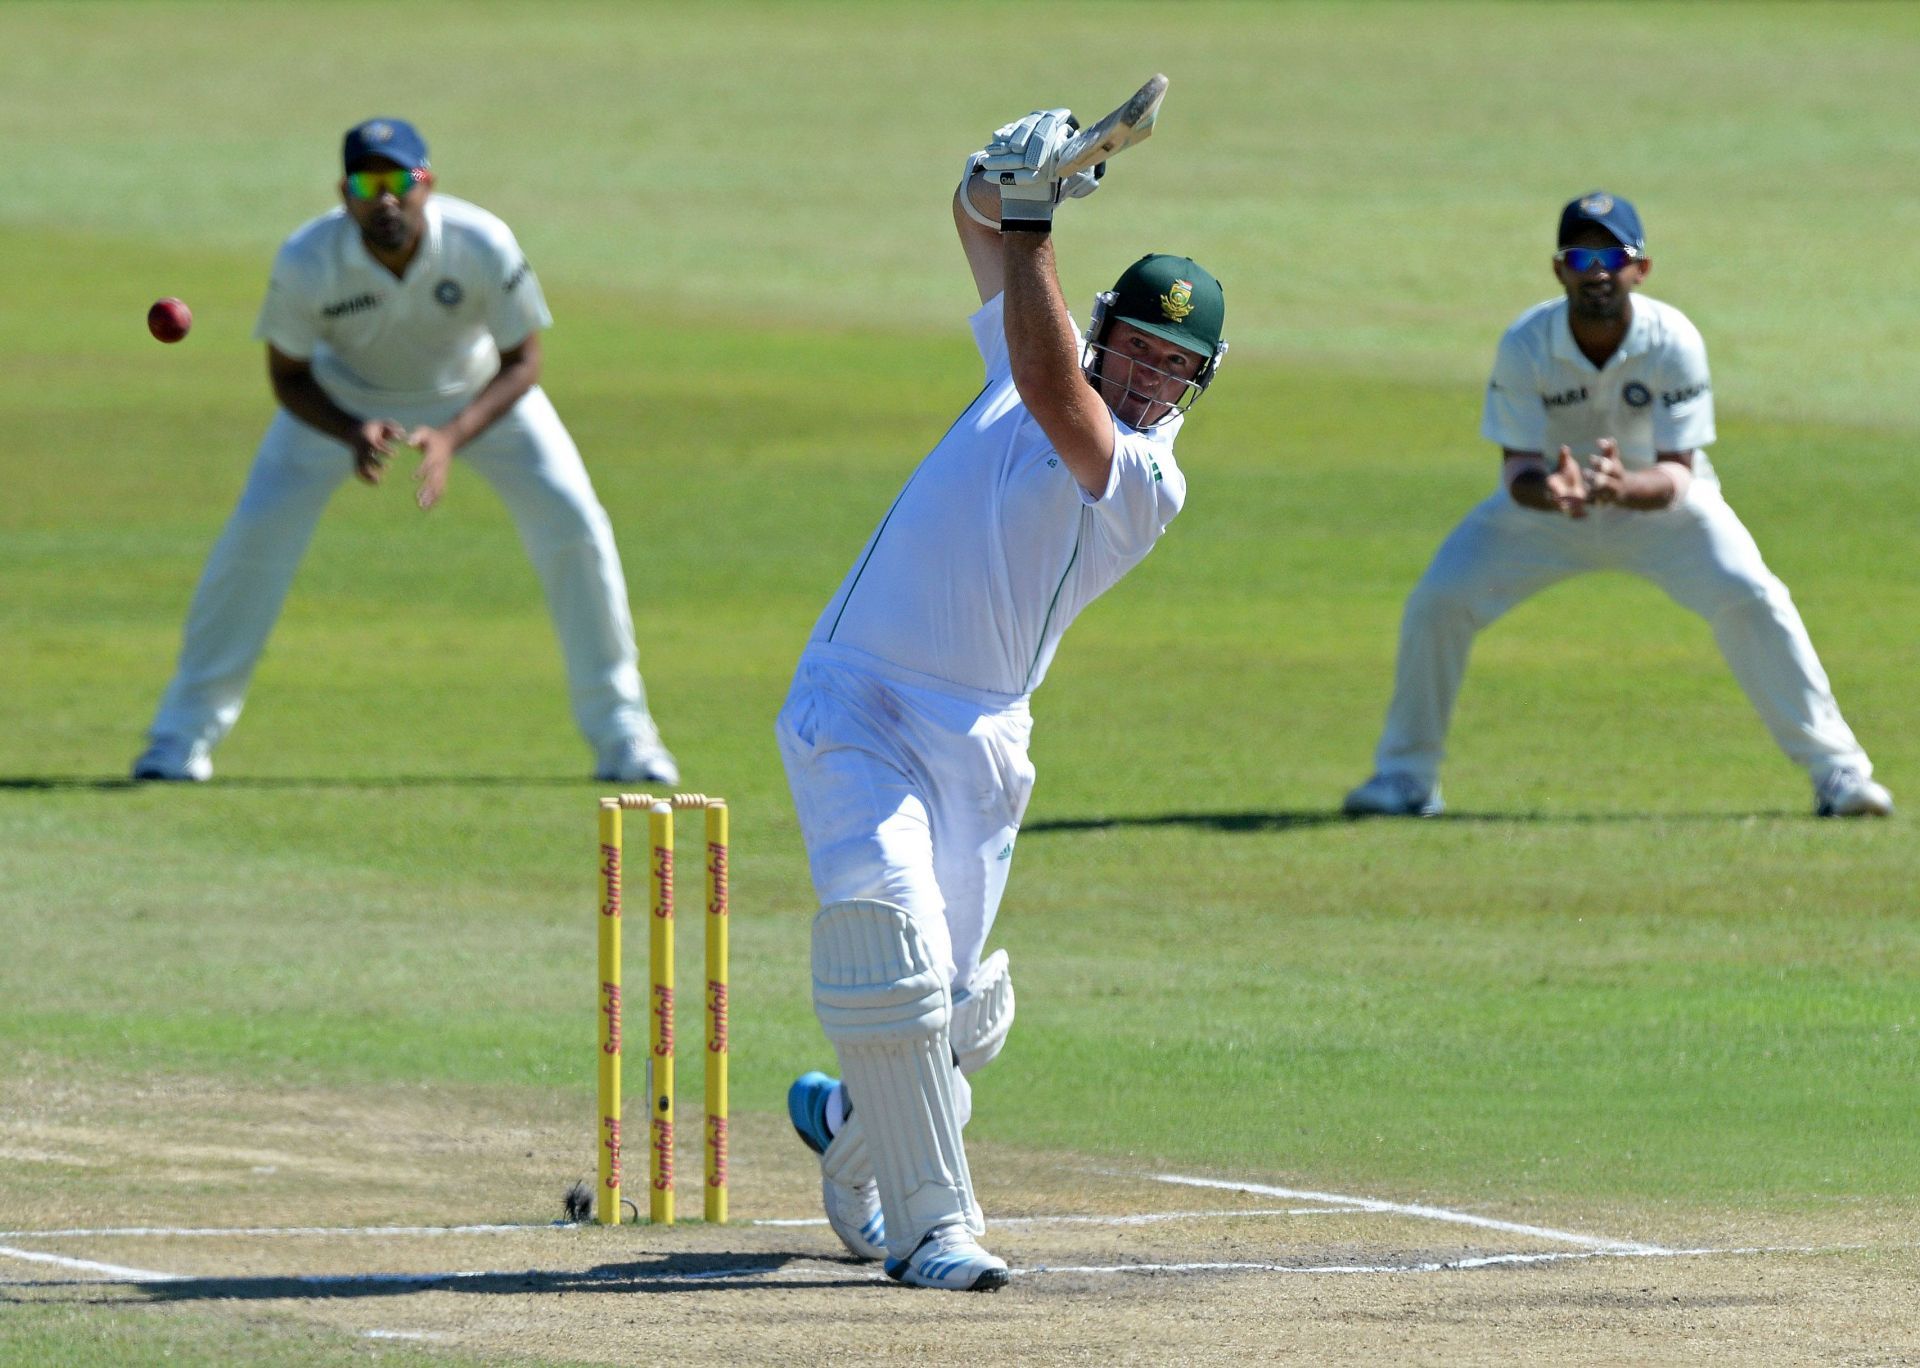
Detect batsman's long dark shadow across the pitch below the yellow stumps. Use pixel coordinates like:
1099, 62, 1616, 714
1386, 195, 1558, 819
50, 1253, 891, 1305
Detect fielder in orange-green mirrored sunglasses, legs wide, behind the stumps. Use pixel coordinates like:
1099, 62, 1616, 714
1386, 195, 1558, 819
132, 119, 680, 784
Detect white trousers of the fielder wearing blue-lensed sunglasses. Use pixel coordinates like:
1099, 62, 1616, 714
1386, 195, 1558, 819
1375, 482, 1872, 786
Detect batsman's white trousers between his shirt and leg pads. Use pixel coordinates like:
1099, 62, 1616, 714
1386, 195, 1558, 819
774, 642, 1033, 991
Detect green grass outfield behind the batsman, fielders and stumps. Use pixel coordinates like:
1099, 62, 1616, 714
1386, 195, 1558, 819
0, 4, 1920, 1362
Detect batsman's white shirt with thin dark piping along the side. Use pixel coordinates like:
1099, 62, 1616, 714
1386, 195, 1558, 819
808, 296, 1187, 697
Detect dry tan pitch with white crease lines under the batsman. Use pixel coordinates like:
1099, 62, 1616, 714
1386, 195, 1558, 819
0, 1063, 1920, 1364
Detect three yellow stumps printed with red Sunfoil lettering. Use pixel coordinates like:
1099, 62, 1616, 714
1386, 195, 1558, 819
593, 794, 728, 1226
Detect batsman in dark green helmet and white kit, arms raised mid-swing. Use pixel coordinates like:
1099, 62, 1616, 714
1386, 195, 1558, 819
776, 110, 1227, 1291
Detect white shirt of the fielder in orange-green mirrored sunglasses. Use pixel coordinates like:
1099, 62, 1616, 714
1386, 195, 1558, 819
253, 194, 553, 417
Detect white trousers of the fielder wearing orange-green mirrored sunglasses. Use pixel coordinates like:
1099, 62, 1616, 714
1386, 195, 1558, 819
150, 386, 651, 749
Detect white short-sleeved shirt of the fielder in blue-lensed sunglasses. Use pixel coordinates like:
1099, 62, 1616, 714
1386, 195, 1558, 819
1480, 294, 1718, 484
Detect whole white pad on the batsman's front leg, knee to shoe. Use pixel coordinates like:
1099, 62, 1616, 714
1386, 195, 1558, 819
814, 899, 973, 1258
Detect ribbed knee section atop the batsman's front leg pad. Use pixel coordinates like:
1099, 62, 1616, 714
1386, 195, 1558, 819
814, 899, 952, 1045
